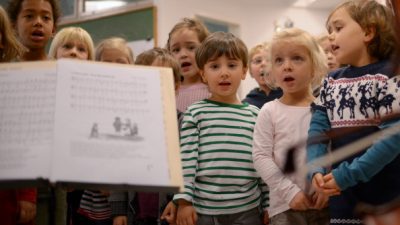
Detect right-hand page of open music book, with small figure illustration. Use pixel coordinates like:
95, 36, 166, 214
53, 60, 169, 186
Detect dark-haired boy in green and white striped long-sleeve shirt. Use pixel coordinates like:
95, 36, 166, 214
170, 32, 268, 225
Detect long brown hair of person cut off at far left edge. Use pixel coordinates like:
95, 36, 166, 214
0, 6, 27, 62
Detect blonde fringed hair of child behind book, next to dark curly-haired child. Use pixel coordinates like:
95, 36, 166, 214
49, 27, 94, 60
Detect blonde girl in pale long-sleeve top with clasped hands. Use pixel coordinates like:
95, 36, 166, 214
253, 28, 329, 225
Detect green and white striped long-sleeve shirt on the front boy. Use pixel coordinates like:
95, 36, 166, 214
174, 100, 269, 215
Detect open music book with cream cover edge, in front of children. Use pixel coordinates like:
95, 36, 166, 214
0, 59, 183, 191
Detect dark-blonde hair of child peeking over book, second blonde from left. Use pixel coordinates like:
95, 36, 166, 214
95, 37, 134, 64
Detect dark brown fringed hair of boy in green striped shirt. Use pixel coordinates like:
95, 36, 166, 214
196, 31, 249, 70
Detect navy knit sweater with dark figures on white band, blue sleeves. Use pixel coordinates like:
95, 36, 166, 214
307, 61, 400, 222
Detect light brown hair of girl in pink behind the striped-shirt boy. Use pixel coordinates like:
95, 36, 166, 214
166, 17, 210, 51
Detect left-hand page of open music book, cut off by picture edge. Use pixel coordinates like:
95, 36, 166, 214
0, 61, 56, 180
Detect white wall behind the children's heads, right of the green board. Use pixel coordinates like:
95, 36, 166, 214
154, 0, 329, 98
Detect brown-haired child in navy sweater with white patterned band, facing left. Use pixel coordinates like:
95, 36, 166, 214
307, 0, 400, 224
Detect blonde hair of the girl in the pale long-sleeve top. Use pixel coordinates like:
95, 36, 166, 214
270, 28, 328, 88
